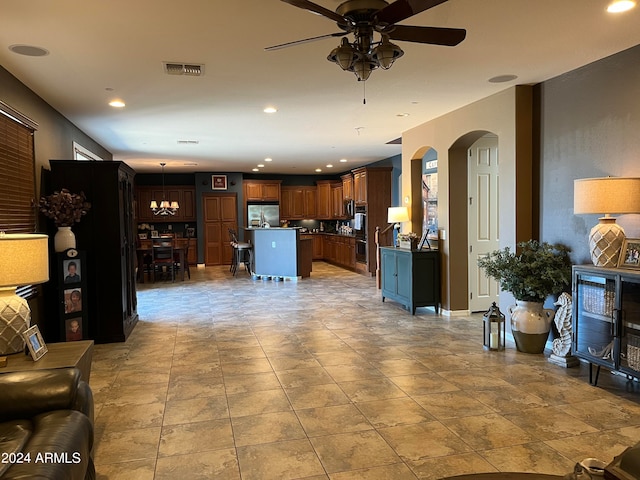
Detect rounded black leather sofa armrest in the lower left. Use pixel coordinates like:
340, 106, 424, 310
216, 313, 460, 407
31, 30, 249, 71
0, 368, 86, 421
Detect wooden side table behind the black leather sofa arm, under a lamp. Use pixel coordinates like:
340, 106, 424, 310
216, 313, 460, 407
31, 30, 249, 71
0, 340, 93, 383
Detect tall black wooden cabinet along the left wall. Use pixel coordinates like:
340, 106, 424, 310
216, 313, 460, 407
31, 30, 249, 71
49, 160, 138, 343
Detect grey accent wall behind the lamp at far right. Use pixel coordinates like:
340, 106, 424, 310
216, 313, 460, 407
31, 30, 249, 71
536, 46, 640, 264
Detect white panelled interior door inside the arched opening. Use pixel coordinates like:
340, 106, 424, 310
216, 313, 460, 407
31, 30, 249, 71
467, 135, 500, 312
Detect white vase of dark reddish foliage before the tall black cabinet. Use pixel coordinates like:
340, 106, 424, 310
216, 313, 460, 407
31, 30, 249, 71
38, 188, 91, 252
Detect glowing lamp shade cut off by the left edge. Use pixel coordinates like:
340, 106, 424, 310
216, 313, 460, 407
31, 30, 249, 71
0, 233, 49, 288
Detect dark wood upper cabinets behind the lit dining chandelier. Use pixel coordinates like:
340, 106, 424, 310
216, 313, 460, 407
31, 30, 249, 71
135, 185, 196, 223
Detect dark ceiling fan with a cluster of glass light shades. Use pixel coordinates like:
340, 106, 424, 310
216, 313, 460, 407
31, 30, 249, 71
265, 0, 467, 81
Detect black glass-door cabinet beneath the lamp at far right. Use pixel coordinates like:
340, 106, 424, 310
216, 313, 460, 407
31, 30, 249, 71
572, 265, 640, 385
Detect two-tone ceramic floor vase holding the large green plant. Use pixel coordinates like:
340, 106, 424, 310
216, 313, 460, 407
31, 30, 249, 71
508, 300, 555, 353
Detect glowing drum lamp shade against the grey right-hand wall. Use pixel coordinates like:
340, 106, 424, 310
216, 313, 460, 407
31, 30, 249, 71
573, 177, 640, 214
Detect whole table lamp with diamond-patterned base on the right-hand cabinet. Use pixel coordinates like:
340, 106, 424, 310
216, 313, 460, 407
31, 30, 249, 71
573, 177, 640, 267
